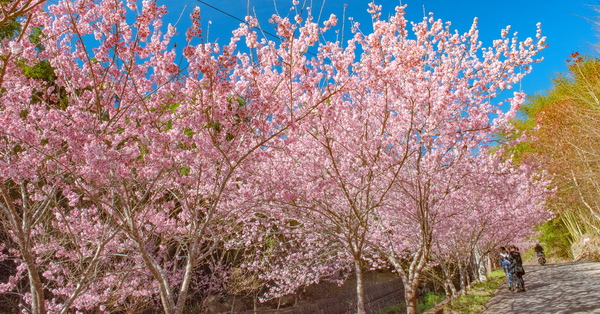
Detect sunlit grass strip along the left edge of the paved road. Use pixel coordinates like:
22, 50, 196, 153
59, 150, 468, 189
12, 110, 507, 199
444, 270, 506, 314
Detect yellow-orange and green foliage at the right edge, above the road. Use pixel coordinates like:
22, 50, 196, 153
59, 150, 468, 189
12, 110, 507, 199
502, 53, 600, 258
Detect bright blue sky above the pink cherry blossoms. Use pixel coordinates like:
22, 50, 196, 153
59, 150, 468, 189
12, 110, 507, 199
158, 0, 600, 98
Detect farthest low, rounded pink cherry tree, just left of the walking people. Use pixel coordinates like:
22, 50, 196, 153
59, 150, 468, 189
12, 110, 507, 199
431, 152, 551, 295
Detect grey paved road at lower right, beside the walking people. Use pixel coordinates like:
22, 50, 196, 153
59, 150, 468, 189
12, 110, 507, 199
483, 261, 600, 314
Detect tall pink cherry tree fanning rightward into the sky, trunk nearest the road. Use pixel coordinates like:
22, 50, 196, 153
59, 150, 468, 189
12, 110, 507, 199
358, 5, 544, 312
